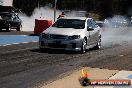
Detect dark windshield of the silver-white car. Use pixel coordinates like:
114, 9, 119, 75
52, 19, 85, 29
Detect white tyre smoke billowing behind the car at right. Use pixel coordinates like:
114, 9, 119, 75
102, 16, 132, 46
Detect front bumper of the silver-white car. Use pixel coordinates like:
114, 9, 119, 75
39, 38, 82, 51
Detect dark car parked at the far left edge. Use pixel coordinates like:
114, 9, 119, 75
0, 12, 22, 31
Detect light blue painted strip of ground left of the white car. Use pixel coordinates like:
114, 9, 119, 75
0, 35, 39, 46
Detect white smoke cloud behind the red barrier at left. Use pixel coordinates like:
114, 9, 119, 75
20, 7, 61, 31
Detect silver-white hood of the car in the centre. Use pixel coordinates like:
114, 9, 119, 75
43, 27, 84, 35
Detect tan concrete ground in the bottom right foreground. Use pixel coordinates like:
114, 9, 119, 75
39, 67, 132, 88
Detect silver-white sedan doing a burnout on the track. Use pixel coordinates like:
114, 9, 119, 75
39, 17, 101, 53
